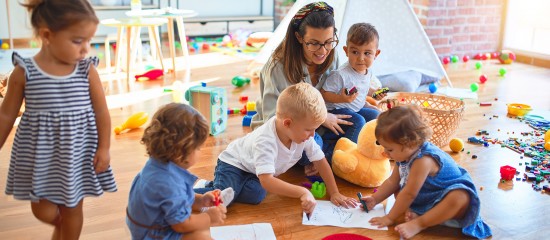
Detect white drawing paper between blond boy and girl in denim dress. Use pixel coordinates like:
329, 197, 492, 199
302, 201, 388, 230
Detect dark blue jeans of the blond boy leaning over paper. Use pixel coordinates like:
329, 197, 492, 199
194, 159, 267, 205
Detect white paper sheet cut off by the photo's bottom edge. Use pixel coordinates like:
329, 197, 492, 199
210, 223, 277, 240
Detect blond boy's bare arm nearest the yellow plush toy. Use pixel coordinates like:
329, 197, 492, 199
313, 158, 357, 208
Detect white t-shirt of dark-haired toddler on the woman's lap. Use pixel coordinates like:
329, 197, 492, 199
323, 62, 376, 112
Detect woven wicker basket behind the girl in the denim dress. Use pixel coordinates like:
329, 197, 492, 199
378, 92, 464, 147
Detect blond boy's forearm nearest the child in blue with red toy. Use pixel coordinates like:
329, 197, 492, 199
258, 174, 317, 213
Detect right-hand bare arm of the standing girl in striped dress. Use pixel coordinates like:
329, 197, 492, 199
89, 65, 111, 173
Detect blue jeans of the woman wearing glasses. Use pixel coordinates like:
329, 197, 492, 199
322, 108, 380, 163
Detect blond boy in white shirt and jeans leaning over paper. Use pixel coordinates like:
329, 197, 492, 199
195, 82, 356, 213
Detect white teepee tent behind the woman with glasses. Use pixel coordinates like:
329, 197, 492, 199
255, 0, 452, 87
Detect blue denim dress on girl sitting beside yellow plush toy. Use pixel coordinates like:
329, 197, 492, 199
396, 142, 492, 238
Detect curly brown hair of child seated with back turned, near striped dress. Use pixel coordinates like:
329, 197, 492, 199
141, 103, 208, 163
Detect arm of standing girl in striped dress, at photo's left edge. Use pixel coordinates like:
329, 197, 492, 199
0, 66, 26, 149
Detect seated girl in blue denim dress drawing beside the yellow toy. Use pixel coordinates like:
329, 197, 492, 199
363, 105, 492, 239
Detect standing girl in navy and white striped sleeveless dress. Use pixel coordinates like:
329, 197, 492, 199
0, 0, 117, 239
